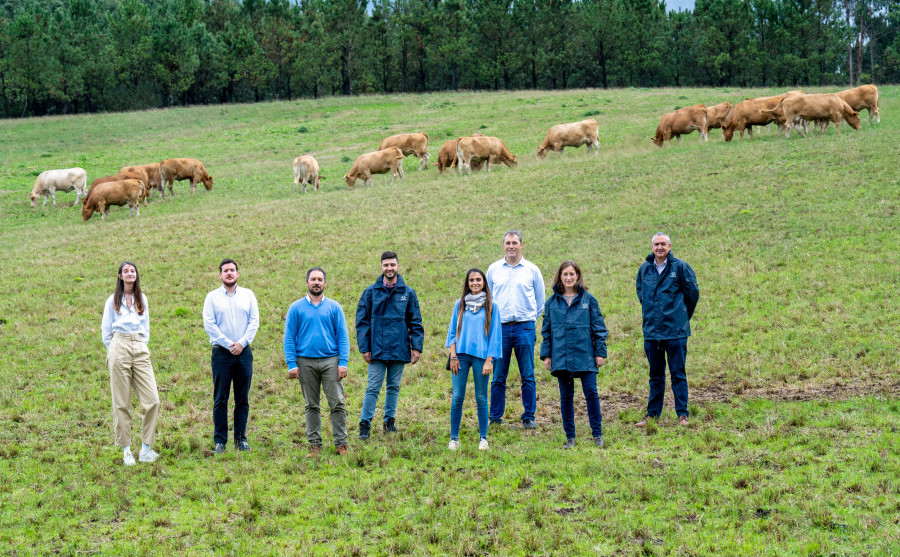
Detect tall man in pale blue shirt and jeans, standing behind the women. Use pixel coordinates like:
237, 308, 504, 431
487, 230, 544, 429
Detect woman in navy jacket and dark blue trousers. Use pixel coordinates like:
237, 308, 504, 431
541, 260, 608, 449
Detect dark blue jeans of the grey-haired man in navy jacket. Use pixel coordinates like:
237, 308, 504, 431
644, 338, 688, 418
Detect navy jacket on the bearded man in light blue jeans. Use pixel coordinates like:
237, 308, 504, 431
356, 275, 425, 363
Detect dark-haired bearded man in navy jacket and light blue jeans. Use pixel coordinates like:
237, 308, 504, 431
356, 251, 425, 439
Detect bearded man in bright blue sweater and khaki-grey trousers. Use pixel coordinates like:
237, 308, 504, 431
284, 267, 350, 458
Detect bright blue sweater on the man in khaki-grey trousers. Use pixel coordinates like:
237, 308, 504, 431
284, 297, 350, 370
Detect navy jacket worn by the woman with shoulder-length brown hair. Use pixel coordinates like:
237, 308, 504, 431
541, 287, 609, 376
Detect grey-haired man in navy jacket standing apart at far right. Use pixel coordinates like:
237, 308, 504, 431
634, 232, 700, 427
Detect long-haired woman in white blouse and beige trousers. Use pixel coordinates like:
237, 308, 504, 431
100, 261, 159, 466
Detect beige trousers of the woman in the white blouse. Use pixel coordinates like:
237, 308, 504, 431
106, 333, 159, 447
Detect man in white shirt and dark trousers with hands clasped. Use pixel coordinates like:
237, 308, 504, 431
203, 259, 259, 454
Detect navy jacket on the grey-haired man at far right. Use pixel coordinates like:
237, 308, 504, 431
635, 251, 700, 340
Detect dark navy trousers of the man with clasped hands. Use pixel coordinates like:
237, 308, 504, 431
211, 346, 253, 445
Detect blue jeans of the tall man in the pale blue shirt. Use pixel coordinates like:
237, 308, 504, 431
491, 321, 537, 422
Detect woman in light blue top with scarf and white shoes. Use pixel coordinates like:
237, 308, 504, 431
446, 269, 503, 451
